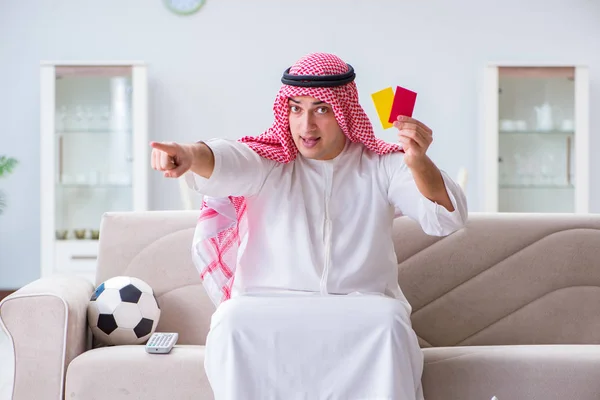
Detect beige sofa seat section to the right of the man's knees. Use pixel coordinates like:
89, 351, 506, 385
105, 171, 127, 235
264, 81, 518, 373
423, 345, 600, 400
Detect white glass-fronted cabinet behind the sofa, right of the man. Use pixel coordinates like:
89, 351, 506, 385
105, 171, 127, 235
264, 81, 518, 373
483, 65, 589, 213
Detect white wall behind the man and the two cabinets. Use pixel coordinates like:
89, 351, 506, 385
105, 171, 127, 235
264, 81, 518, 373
0, 0, 600, 288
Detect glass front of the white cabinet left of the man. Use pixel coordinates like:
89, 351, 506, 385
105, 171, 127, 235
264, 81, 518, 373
54, 66, 133, 240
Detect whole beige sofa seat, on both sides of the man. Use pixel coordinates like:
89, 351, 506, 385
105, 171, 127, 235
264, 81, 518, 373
65, 345, 600, 400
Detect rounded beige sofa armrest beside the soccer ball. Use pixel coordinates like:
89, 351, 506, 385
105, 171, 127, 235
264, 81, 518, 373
0, 276, 94, 400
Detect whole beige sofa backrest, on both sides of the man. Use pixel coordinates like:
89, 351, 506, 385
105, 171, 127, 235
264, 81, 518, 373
96, 211, 600, 347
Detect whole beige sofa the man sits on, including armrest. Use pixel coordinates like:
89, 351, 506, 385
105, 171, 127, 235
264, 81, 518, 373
0, 211, 600, 400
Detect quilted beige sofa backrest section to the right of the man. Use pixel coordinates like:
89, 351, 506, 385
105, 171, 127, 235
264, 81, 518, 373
395, 213, 600, 347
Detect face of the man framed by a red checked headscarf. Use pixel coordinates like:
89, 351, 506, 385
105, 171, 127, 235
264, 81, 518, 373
288, 96, 346, 160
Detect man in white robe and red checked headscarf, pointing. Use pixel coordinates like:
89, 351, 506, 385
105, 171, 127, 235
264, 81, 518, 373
151, 53, 467, 400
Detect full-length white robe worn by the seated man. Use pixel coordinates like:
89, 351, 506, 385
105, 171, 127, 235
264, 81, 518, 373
189, 139, 467, 400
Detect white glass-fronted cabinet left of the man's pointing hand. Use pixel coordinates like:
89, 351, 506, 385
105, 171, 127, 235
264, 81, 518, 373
40, 62, 149, 282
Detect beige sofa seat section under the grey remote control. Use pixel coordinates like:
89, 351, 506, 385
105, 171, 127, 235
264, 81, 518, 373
65, 345, 213, 400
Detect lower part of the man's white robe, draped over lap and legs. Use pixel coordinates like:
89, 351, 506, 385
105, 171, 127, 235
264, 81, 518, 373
204, 294, 423, 400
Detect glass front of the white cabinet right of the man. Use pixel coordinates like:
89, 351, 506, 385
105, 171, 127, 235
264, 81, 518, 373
498, 67, 576, 212
